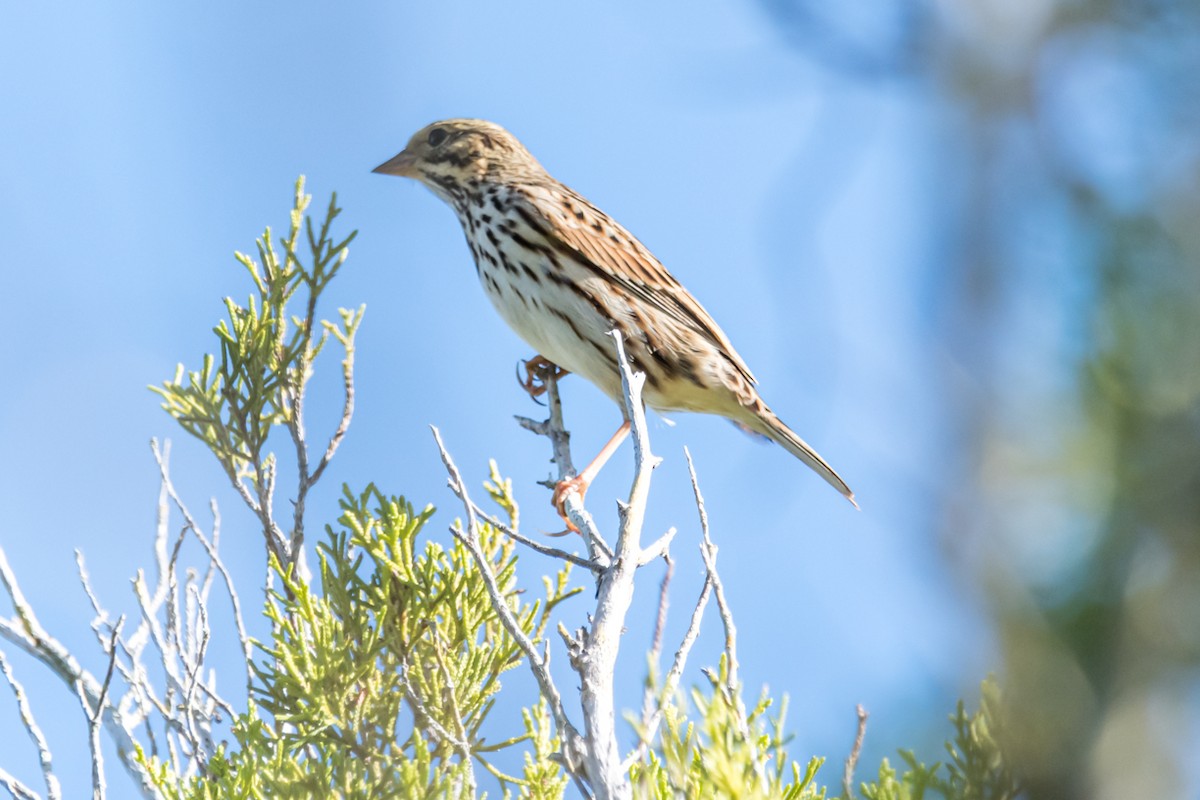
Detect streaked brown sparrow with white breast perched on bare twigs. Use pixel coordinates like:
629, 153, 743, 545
374, 120, 858, 511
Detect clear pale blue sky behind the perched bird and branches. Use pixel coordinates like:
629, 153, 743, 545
0, 1, 994, 795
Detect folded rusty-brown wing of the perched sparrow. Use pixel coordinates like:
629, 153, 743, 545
517, 185, 758, 384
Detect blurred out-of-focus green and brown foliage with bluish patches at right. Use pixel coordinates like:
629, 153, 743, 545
762, 0, 1200, 800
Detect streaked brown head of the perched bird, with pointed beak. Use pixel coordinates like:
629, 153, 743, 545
372, 120, 544, 199
